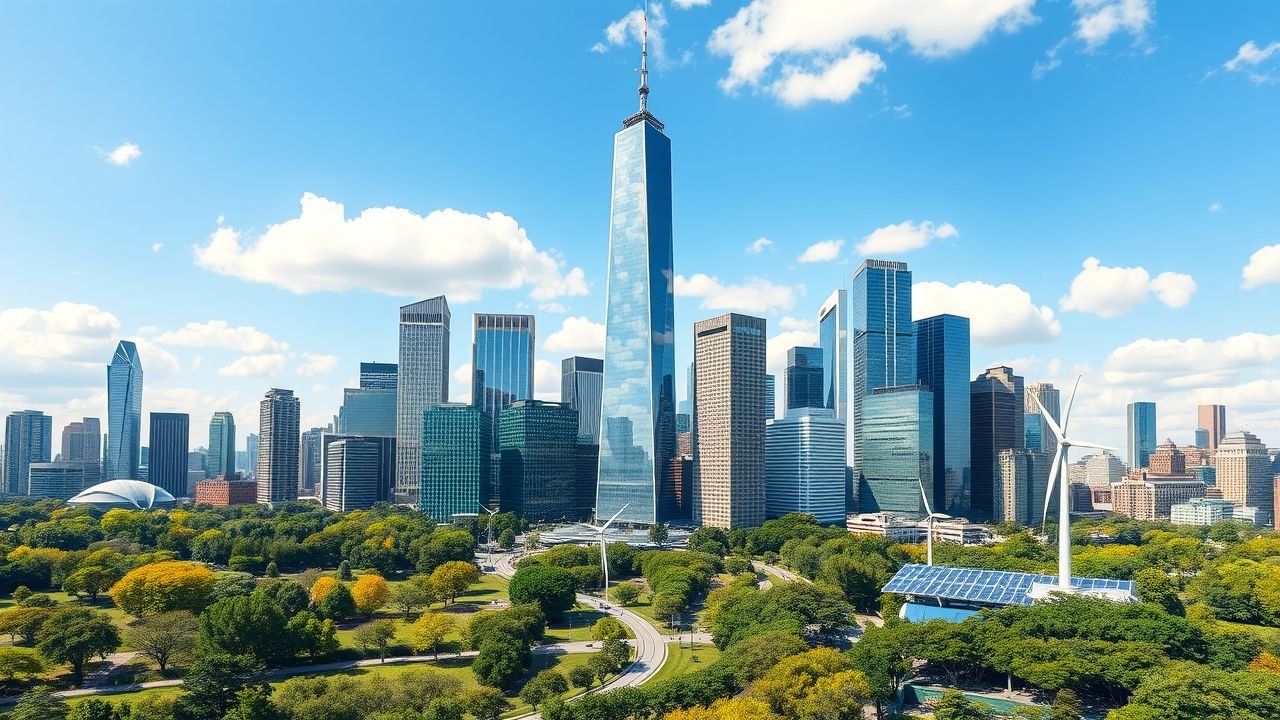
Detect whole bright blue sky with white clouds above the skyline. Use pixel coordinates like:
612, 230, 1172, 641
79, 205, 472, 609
0, 0, 1280, 456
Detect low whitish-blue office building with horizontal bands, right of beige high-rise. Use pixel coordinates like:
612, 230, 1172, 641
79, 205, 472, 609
764, 406, 845, 525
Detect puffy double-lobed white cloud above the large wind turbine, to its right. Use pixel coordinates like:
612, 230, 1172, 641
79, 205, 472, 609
1059, 258, 1196, 318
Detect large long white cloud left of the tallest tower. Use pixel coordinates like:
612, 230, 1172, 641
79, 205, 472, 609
195, 192, 588, 302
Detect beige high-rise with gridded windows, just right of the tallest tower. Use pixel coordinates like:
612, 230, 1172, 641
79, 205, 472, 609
692, 313, 765, 529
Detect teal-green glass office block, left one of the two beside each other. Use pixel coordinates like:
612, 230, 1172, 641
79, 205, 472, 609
420, 402, 495, 523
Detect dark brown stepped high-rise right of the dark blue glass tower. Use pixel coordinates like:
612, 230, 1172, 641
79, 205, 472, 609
969, 366, 1027, 519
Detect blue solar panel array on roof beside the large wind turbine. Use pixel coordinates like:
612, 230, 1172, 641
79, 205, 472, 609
883, 565, 1133, 605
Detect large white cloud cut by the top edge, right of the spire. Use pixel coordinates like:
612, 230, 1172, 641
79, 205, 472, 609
708, 0, 1036, 105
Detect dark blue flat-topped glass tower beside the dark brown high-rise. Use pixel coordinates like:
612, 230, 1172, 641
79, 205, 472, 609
915, 315, 973, 516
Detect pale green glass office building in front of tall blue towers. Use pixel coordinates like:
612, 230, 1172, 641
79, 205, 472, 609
858, 386, 936, 516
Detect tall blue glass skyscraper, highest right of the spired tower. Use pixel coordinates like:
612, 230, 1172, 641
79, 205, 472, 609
849, 260, 916, 478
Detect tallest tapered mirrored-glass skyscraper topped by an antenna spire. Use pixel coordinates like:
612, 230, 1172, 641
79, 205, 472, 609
595, 30, 680, 524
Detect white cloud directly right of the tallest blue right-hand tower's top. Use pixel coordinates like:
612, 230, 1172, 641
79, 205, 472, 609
911, 282, 1062, 346
